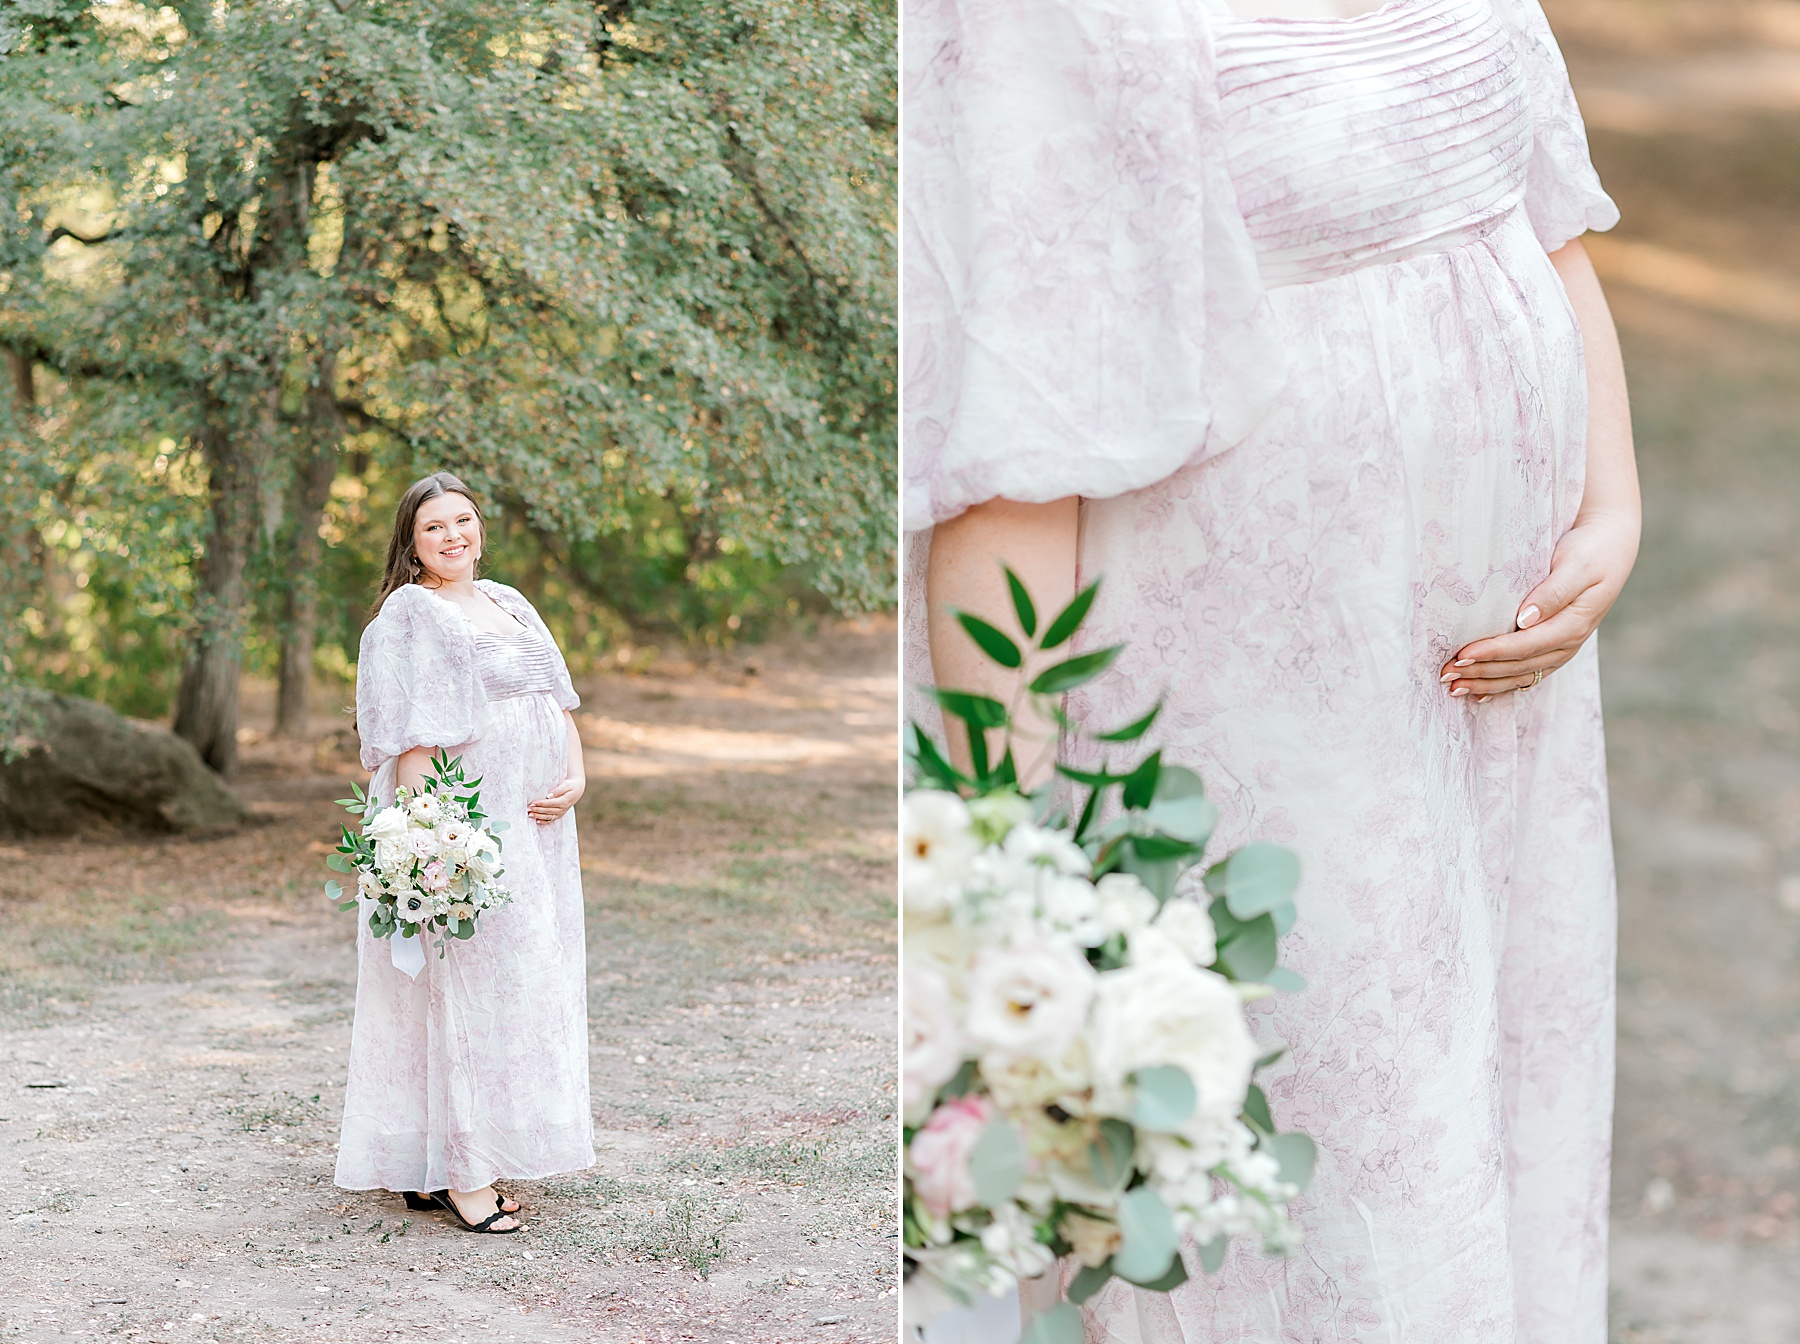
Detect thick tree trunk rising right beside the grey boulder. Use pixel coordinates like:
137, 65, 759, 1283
175, 407, 257, 775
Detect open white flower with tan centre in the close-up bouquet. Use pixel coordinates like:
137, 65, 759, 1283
963, 943, 1094, 1065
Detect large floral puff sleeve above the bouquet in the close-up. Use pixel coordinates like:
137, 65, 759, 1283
902, 0, 1285, 531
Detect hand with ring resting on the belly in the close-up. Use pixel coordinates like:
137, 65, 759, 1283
1440, 515, 1638, 702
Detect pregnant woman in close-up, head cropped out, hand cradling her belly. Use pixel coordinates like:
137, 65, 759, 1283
905, 0, 1638, 1344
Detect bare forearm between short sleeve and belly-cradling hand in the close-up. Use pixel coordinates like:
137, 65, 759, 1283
1550, 239, 1642, 543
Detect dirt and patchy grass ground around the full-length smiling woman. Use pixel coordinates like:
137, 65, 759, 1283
0, 624, 898, 1344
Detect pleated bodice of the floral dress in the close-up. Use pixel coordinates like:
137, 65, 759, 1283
1211, 0, 1532, 288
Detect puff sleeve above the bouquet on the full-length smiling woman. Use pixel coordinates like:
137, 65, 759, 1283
356, 585, 488, 772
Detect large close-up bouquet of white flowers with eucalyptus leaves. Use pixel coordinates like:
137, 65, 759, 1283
902, 572, 1314, 1344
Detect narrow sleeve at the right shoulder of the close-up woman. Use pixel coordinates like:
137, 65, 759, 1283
1492, 0, 1618, 252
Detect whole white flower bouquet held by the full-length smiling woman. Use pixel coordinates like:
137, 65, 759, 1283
326, 752, 511, 957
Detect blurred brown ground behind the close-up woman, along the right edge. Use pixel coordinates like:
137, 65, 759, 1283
1548, 0, 1800, 1344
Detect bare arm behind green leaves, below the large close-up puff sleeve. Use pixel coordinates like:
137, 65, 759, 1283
925, 498, 1076, 788
